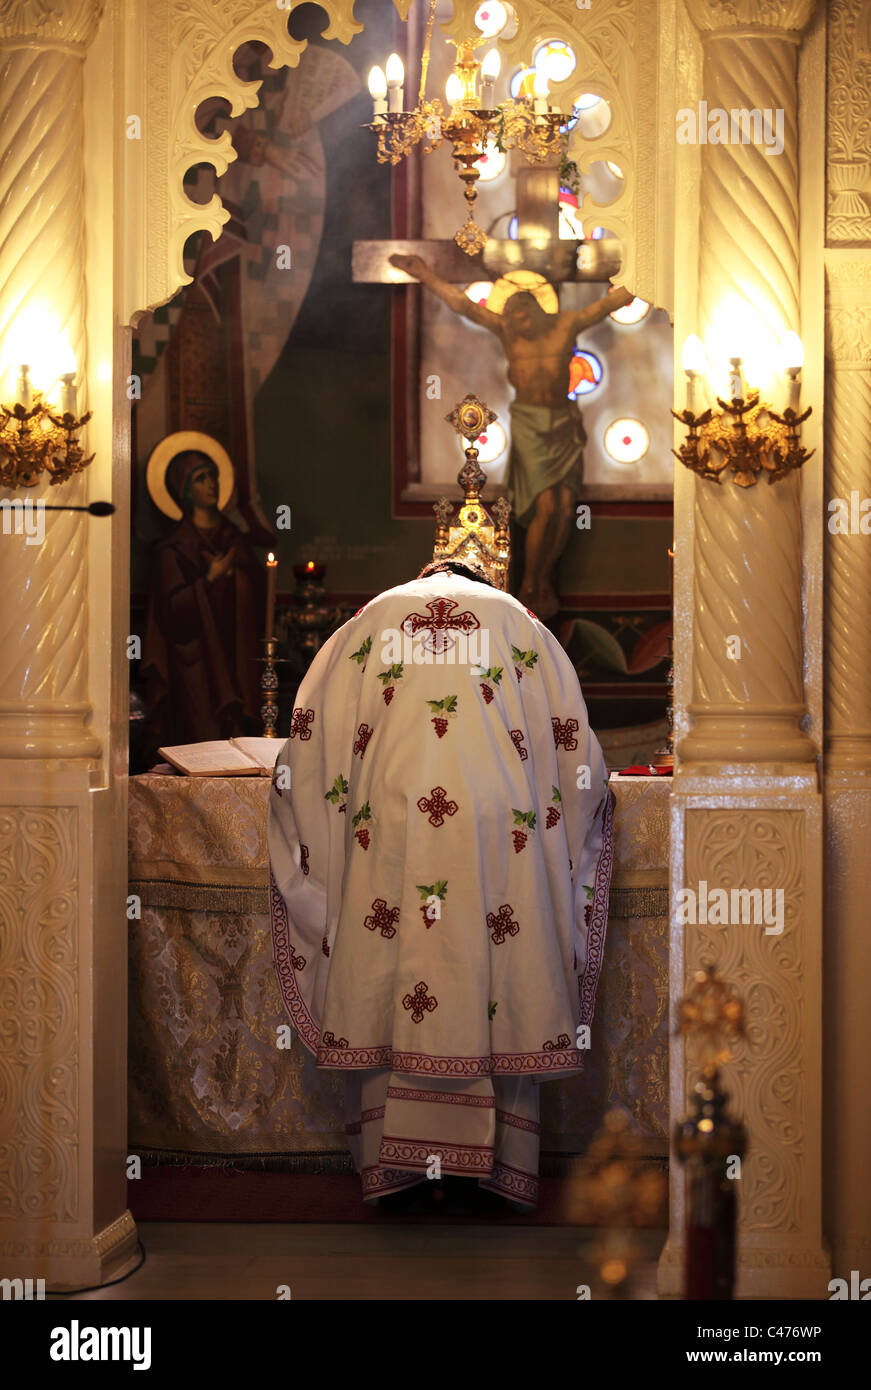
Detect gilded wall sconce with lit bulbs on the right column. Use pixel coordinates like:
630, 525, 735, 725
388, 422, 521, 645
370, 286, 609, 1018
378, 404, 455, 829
671, 332, 813, 488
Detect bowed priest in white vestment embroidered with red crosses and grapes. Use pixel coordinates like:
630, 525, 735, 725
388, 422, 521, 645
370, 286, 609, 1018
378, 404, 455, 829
269, 570, 613, 1207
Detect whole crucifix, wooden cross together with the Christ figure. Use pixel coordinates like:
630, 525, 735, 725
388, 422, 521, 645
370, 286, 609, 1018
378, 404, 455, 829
353, 154, 632, 620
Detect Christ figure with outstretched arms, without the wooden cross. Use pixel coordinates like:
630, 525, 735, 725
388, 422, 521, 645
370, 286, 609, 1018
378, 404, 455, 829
390, 254, 632, 619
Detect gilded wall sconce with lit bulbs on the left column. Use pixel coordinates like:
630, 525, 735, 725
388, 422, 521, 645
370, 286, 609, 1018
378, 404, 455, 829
0, 364, 94, 491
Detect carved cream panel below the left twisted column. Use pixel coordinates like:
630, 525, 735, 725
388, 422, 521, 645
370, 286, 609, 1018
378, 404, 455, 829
0, 806, 81, 1222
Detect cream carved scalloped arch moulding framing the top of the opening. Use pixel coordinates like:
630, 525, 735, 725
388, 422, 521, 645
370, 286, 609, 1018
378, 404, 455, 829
121, 0, 674, 324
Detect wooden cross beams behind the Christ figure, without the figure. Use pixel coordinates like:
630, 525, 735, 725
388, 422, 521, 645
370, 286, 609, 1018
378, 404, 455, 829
351, 152, 621, 286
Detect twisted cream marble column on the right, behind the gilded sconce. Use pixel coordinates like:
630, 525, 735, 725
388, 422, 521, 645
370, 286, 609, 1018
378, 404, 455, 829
679, 0, 814, 765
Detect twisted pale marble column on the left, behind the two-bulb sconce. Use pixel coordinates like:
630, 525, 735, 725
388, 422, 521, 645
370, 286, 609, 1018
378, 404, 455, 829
0, 0, 101, 758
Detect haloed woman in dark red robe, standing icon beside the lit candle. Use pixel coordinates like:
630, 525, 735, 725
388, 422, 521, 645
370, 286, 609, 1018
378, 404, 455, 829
143, 430, 265, 748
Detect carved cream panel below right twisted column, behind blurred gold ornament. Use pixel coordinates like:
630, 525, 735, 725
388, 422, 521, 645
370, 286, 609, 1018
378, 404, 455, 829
685, 808, 808, 1234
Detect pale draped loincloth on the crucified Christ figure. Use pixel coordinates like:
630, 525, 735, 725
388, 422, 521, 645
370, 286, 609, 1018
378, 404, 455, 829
507, 400, 586, 525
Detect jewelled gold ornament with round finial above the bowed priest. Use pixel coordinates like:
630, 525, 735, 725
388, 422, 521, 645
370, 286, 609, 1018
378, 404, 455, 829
432, 396, 511, 589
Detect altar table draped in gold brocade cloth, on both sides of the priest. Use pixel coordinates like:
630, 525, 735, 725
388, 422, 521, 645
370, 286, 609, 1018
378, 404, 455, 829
128, 773, 671, 1172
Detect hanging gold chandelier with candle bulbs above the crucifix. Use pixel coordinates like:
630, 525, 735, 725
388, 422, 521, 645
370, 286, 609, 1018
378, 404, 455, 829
367, 0, 565, 256
